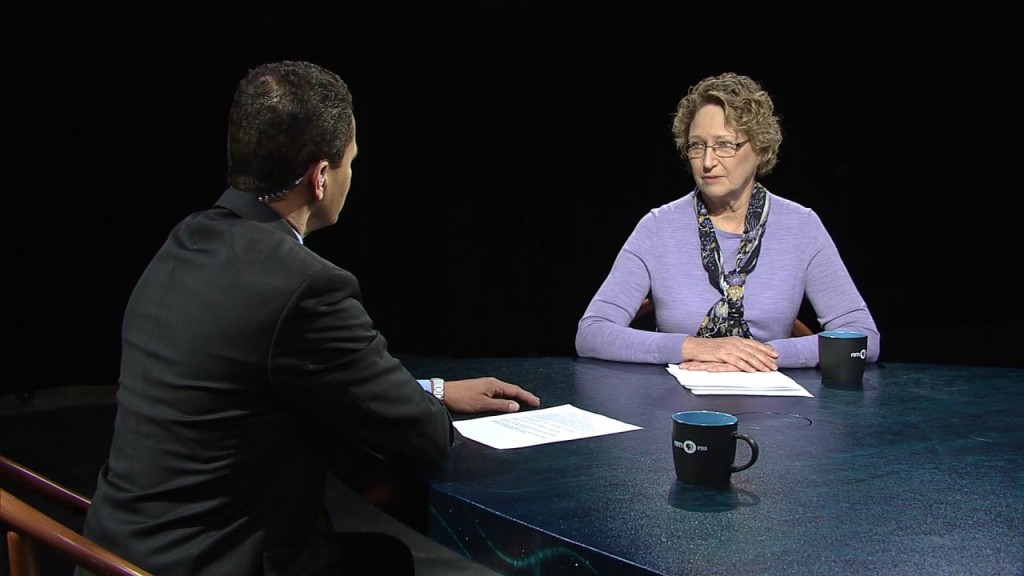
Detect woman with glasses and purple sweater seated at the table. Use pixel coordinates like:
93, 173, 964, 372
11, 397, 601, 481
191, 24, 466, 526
575, 73, 880, 372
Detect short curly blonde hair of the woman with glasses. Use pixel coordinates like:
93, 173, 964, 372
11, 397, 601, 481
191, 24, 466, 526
672, 72, 782, 176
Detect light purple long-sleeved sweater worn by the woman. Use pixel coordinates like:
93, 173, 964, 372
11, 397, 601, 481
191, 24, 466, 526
575, 192, 880, 368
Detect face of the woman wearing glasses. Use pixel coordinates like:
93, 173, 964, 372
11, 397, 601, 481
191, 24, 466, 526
687, 104, 759, 203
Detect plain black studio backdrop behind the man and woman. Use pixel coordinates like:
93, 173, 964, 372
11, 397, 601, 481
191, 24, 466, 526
0, 1, 1024, 392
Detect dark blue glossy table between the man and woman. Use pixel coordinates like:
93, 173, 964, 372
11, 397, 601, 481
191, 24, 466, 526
407, 358, 1024, 576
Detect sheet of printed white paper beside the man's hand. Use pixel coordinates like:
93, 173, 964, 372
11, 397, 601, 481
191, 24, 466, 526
455, 404, 641, 450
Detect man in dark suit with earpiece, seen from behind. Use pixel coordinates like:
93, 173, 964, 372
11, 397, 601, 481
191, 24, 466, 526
78, 61, 540, 576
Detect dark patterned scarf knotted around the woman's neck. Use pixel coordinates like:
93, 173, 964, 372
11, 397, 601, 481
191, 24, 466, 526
693, 182, 770, 338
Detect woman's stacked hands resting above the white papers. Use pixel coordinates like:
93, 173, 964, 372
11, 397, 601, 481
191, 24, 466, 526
679, 336, 778, 372
